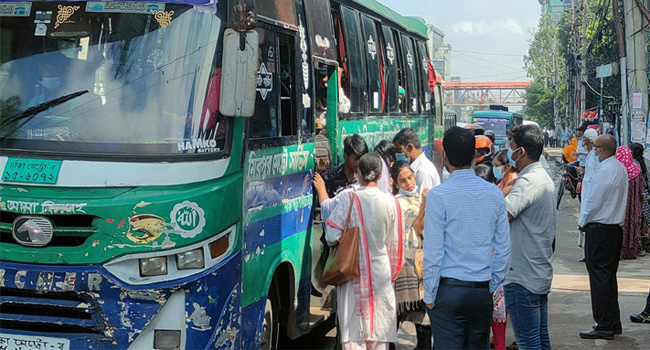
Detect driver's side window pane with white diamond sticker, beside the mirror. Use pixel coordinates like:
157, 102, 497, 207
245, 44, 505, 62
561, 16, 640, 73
248, 26, 279, 138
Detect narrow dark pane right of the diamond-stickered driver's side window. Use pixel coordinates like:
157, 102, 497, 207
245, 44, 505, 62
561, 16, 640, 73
278, 34, 298, 136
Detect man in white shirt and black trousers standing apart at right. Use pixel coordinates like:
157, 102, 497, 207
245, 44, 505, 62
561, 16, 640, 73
578, 135, 629, 340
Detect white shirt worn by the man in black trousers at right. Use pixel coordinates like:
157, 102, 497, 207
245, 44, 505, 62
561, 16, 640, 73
578, 156, 629, 227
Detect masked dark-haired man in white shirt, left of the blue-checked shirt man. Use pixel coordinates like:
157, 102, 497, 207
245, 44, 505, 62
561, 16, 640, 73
393, 128, 440, 195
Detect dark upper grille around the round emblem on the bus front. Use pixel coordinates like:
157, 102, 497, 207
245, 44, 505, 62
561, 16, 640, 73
0, 211, 95, 247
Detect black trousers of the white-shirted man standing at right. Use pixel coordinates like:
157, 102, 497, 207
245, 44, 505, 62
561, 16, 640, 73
585, 224, 623, 331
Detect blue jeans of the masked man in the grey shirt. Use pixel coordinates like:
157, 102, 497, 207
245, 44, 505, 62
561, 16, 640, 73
505, 283, 551, 350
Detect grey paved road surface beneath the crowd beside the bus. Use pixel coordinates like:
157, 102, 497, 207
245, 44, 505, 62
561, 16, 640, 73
295, 151, 650, 350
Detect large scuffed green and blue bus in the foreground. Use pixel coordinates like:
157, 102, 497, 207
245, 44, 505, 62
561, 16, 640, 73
0, 0, 443, 349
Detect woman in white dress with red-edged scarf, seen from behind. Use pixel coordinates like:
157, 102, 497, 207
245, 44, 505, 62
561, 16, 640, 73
325, 153, 404, 350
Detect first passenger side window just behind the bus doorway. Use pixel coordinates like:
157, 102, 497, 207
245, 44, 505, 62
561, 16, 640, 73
341, 6, 366, 113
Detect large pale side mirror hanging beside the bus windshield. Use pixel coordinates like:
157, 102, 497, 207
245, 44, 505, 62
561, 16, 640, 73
219, 28, 259, 117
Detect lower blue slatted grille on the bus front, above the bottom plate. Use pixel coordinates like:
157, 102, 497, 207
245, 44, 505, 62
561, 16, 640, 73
0, 288, 106, 336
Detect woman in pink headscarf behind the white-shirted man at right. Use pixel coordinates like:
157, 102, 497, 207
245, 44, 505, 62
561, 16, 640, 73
616, 146, 643, 259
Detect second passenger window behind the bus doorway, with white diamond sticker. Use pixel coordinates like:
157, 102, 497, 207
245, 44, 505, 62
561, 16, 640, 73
361, 15, 383, 112
